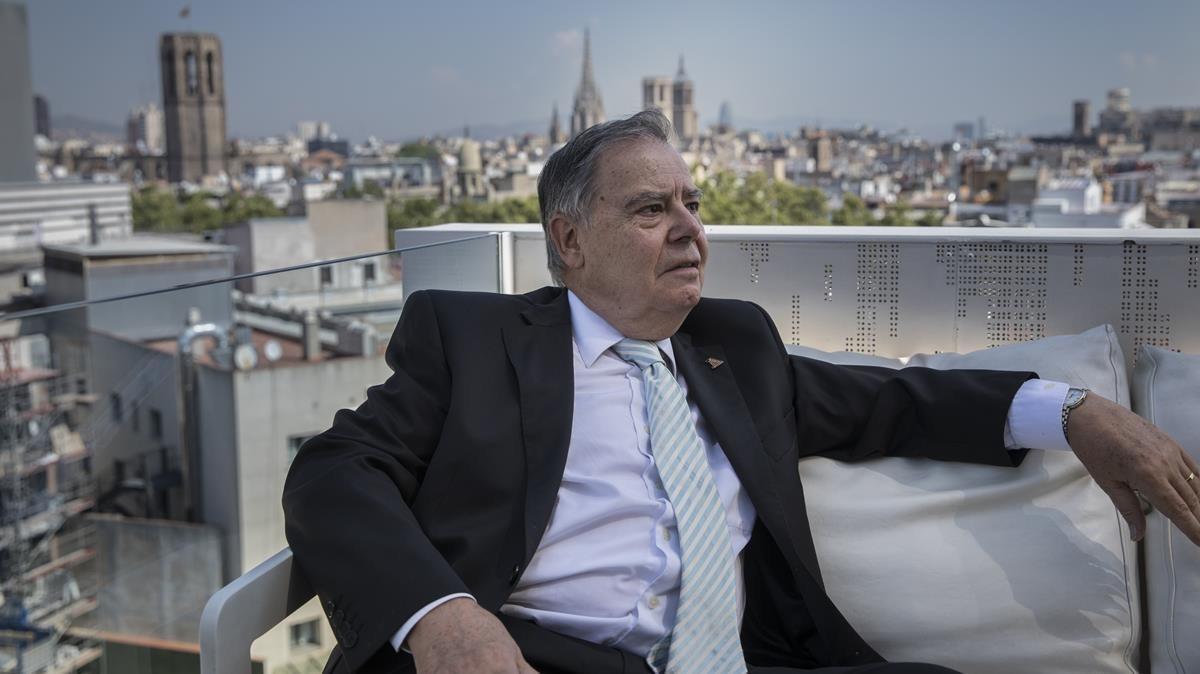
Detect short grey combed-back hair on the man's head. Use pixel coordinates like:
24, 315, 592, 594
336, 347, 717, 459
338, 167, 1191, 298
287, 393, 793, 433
538, 110, 671, 285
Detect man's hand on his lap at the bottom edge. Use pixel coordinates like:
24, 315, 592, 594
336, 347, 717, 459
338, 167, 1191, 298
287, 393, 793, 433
408, 597, 536, 674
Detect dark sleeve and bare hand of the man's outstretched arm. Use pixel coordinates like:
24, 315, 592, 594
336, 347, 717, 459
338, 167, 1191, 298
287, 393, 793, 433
758, 307, 1200, 546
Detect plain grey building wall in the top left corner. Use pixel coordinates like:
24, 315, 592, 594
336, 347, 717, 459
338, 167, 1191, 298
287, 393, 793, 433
0, 2, 37, 182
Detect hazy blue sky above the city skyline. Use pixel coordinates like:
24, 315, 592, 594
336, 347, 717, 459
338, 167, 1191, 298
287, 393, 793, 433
18, 0, 1200, 139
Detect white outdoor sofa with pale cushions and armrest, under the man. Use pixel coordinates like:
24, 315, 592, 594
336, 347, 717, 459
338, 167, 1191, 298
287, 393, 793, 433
200, 325, 1200, 674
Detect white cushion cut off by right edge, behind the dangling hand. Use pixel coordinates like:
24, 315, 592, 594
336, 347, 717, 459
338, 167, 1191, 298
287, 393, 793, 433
1130, 347, 1200, 674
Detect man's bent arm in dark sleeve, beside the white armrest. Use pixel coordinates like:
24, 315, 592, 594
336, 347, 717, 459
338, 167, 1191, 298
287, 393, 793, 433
283, 293, 484, 669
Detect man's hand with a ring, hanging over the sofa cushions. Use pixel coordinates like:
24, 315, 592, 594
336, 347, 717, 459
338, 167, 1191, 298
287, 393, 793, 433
1067, 392, 1200, 546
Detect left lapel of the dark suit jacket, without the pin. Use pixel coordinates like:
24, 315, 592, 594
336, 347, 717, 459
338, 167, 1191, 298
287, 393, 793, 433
504, 291, 575, 561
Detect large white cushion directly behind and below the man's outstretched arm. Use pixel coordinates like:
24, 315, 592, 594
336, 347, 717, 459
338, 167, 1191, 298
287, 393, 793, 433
796, 326, 1140, 674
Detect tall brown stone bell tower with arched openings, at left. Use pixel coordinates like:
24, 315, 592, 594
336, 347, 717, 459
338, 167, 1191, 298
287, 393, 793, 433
158, 32, 226, 182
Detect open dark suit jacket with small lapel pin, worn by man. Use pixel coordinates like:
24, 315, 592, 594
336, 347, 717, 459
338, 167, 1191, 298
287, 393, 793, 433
283, 288, 1032, 672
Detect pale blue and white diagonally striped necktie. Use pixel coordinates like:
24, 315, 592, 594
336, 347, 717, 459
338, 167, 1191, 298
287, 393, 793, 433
612, 339, 746, 674
